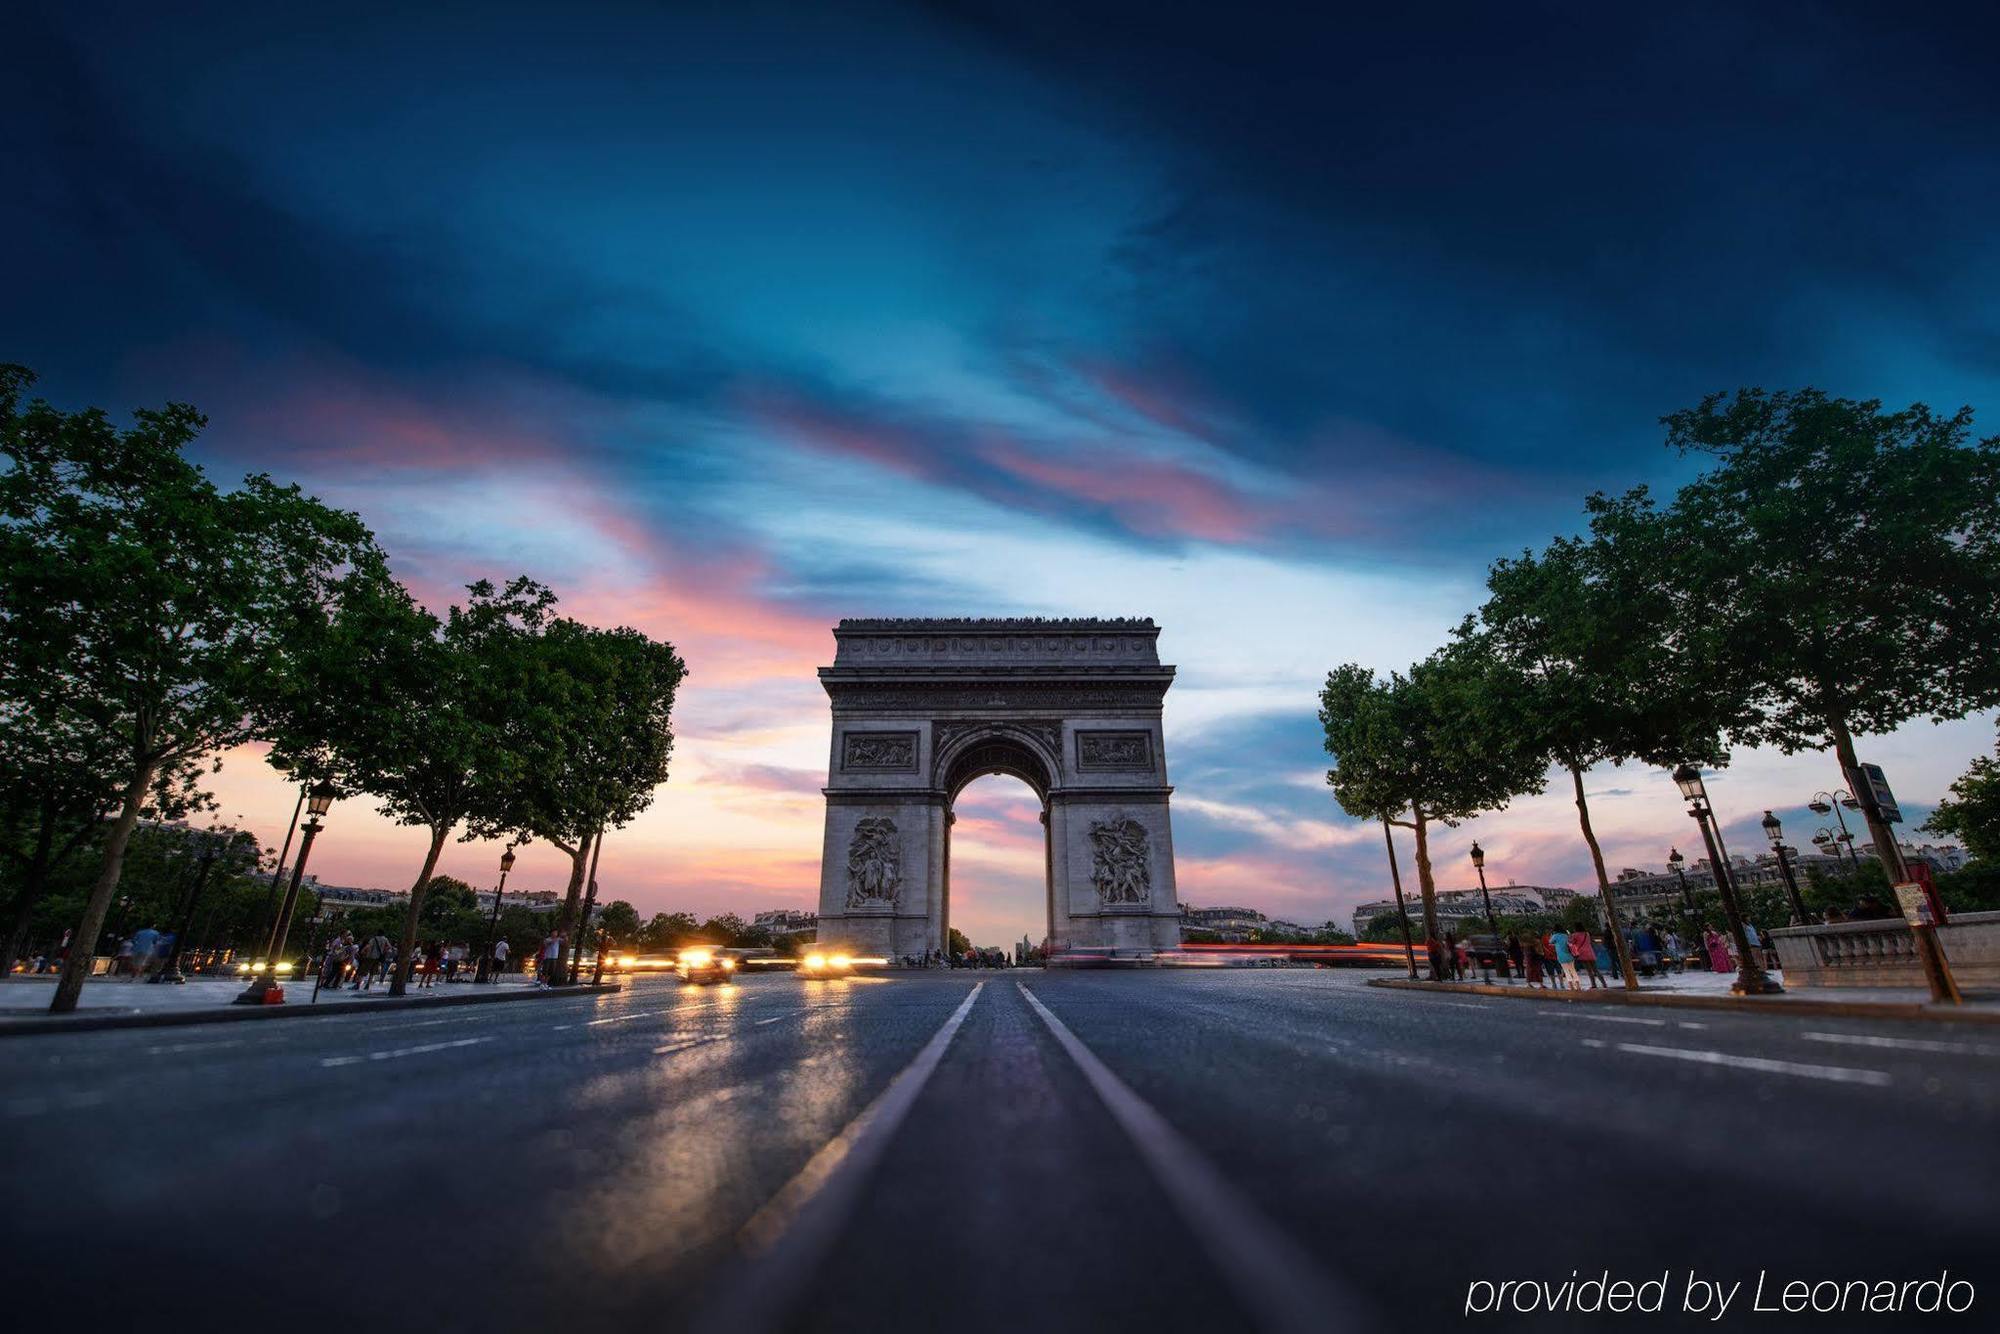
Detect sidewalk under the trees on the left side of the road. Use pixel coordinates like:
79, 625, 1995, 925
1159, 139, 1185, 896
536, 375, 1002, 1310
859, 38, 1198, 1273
0, 974, 622, 1036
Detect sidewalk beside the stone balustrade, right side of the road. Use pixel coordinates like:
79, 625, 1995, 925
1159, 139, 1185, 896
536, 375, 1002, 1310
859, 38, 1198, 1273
1368, 968, 2000, 1024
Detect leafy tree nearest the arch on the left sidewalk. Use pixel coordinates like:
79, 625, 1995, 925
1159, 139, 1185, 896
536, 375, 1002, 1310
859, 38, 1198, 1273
474, 618, 688, 930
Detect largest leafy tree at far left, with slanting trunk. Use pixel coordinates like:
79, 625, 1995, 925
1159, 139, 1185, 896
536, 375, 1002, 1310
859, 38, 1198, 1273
0, 368, 378, 1014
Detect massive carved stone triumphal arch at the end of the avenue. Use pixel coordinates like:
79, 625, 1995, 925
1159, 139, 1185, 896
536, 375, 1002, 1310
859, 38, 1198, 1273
820, 620, 1180, 958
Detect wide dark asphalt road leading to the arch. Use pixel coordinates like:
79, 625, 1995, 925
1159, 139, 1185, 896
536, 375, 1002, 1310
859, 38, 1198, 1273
0, 970, 2000, 1332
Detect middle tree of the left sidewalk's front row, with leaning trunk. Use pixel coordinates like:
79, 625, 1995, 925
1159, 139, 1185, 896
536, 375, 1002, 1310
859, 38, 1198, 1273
272, 570, 554, 996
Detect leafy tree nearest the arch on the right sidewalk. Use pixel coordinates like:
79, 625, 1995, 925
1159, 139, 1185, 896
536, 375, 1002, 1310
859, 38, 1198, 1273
1320, 634, 1546, 978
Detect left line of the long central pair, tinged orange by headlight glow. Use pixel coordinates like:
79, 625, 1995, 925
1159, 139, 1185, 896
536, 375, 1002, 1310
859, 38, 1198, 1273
692, 982, 986, 1334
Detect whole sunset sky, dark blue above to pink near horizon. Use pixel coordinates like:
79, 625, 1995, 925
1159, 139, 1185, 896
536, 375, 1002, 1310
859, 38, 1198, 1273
0, 0, 2000, 942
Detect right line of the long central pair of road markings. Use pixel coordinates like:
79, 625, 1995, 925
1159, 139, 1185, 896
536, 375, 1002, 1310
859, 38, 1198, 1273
1014, 982, 1384, 1334
